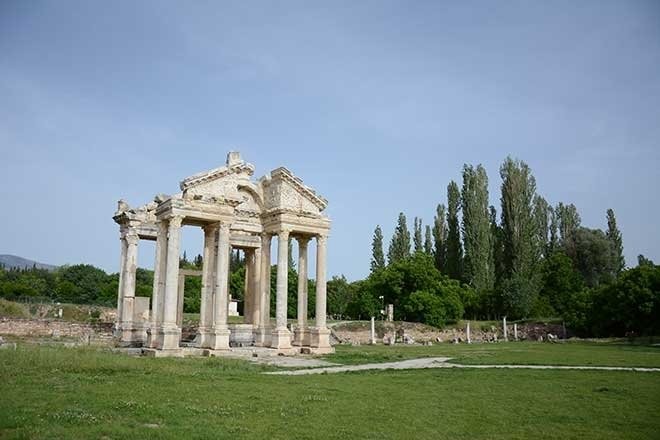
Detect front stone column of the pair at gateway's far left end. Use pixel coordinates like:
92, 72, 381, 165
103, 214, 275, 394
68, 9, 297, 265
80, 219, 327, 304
121, 229, 142, 344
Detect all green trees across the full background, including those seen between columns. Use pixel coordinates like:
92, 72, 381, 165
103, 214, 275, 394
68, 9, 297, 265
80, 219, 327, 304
0, 158, 660, 336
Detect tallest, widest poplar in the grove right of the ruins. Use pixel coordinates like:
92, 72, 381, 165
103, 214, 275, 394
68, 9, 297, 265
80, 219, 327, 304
500, 157, 539, 317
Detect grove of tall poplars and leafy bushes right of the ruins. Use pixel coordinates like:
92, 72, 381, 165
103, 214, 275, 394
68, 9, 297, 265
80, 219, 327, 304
346, 158, 660, 336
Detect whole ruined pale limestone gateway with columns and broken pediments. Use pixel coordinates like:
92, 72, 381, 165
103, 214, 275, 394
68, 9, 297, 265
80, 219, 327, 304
113, 152, 333, 356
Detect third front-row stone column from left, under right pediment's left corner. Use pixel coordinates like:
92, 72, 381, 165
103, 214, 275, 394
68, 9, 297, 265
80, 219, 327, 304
270, 230, 291, 349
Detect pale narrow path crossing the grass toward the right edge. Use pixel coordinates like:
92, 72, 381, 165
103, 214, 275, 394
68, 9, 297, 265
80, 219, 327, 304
264, 357, 660, 376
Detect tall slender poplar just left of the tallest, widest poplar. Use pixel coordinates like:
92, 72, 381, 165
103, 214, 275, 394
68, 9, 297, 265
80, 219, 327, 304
461, 164, 495, 294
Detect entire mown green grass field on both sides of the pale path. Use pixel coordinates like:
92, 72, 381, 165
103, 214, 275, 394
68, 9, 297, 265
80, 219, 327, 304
0, 343, 660, 440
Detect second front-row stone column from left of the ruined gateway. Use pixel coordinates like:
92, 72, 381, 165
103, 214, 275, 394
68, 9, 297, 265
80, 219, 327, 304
211, 223, 229, 350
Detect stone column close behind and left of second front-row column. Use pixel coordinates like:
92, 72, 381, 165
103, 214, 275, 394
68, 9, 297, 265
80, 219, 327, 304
198, 224, 218, 348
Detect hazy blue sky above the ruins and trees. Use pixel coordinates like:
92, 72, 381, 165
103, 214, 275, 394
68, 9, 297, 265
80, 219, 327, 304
0, 0, 660, 279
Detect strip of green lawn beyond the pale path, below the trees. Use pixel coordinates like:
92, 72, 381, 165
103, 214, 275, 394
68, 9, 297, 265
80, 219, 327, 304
325, 342, 660, 367
